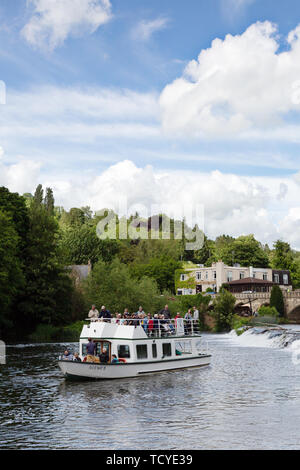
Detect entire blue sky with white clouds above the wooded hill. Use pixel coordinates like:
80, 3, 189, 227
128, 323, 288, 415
0, 0, 300, 249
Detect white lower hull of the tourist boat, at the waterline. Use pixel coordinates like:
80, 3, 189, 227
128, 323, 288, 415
58, 354, 211, 380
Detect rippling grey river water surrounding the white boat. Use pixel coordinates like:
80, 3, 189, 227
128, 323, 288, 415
0, 334, 300, 450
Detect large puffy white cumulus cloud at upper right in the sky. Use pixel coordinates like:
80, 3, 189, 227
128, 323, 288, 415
160, 21, 300, 139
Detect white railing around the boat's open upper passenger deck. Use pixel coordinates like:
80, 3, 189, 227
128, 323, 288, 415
86, 317, 200, 338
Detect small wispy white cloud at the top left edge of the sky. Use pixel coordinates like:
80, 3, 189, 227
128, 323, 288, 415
22, 0, 112, 50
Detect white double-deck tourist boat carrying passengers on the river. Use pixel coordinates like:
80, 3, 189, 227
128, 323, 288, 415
59, 319, 211, 379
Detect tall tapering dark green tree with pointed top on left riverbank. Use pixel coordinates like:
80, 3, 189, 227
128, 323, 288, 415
19, 185, 72, 331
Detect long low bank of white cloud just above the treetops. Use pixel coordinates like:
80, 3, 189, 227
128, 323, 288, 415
0, 158, 300, 249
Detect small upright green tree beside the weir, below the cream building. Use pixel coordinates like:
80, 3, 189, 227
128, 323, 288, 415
213, 289, 236, 332
